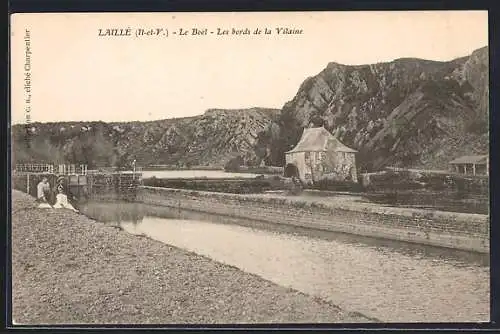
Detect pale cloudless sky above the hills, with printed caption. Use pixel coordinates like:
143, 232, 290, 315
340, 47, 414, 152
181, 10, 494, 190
11, 11, 488, 124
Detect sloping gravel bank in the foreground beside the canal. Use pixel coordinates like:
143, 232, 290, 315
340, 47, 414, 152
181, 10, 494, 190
12, 191, 371, 324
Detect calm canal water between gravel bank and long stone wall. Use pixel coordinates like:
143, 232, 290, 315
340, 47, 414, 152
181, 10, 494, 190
78, 203, 490, 322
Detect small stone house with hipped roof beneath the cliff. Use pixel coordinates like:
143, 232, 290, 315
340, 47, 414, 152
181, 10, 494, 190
284, 127, 358, 184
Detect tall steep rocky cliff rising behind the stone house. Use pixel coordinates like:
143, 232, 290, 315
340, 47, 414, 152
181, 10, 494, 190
260, 47, 488, 170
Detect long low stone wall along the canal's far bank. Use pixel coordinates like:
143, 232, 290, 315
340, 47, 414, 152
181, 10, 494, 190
138, 186, 489, 253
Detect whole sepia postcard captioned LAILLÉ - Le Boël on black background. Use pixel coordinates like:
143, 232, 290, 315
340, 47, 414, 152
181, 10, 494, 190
10, 11, 490, 326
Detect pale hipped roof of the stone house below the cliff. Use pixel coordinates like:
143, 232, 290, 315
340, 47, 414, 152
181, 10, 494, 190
286, 127, 357, 153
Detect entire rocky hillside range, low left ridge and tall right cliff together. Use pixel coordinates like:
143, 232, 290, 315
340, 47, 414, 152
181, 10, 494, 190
13, 47, 489, 171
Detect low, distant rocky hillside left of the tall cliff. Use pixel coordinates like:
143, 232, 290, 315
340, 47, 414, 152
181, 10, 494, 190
12, 108, 279, 167
